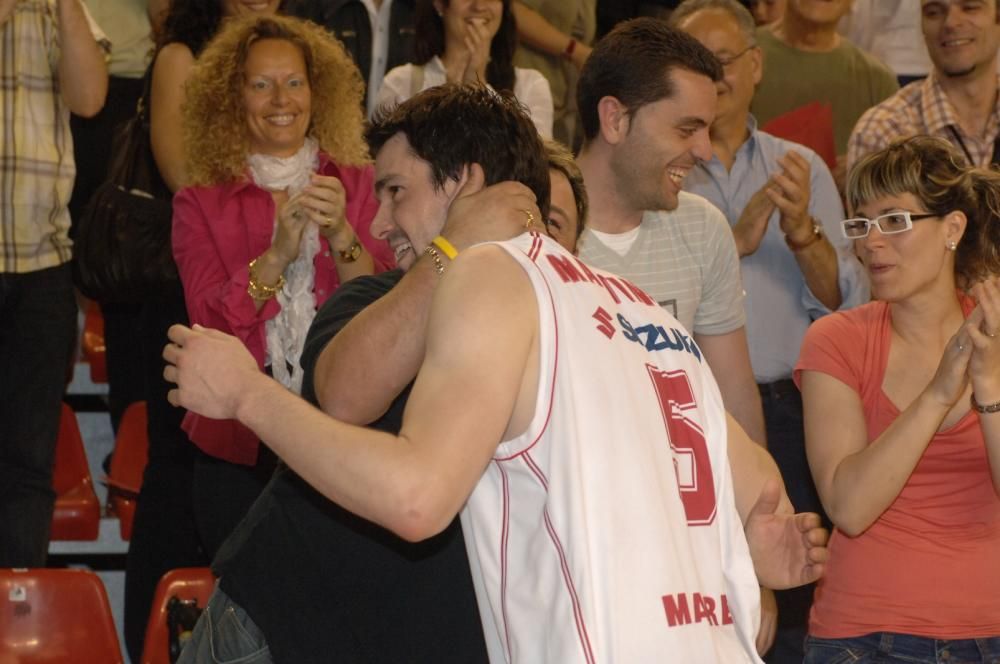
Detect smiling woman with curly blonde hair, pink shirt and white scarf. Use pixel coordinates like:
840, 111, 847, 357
173, 16, 392, 564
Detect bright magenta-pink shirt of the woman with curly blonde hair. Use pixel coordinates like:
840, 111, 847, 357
172, 152, 395, 465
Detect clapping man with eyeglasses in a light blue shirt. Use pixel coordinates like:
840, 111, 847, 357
670, 0, 868, 662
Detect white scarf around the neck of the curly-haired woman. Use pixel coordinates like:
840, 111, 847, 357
247, 137, 319, 393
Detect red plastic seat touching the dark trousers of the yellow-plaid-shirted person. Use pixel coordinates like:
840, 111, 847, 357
50, 403, 101, 540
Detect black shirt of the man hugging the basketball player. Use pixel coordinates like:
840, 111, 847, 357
213, 270, 487, 664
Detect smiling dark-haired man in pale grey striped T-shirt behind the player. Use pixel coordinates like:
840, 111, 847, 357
577, 18, 765, 456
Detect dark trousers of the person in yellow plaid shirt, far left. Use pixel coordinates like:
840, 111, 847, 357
0, 265, 77, 567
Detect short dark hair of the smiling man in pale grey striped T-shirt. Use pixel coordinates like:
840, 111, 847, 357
576, 17, 722, 141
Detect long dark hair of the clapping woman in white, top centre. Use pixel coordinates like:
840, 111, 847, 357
413, 0, 517, 92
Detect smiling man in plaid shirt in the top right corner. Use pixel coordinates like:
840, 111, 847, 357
847, 0, 1000, 166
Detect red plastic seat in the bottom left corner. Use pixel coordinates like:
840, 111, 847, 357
0, 569, 123, 664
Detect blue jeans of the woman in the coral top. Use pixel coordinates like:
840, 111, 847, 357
804, 632, 1000, 664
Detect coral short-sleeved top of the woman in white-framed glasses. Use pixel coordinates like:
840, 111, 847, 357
795, 297, 1000, 639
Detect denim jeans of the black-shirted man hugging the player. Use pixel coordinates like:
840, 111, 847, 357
177, 584, 274, 664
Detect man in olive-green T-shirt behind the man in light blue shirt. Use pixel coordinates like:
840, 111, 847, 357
751, 0, 899, 191
